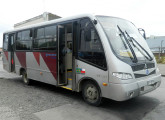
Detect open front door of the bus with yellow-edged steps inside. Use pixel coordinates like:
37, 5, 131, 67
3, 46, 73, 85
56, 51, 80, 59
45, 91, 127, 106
58, 23, 73, 86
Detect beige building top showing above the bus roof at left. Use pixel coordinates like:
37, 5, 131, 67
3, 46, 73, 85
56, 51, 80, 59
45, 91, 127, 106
14, 12, 61, 28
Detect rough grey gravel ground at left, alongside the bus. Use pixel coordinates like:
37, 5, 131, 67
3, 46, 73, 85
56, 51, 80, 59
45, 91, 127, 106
0, 78, 82, 120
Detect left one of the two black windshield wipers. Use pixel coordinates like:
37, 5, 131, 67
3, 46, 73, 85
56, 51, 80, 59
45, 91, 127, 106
117, 25, 138, 63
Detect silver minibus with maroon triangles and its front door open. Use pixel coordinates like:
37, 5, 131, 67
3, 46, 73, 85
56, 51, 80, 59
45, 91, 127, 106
3, 14, 161, 105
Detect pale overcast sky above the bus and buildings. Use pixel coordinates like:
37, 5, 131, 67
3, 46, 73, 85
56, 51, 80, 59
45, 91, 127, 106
0, 0, 165, 47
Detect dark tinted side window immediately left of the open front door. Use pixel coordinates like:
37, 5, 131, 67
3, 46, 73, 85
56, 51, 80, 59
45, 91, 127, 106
34, 26, 56, 50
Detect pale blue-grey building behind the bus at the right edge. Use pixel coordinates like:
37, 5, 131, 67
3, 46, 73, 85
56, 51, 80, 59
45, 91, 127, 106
146, 36, 165, 54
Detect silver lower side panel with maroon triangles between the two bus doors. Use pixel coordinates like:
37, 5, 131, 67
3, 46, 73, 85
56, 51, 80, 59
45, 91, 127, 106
15, 52, 57, 85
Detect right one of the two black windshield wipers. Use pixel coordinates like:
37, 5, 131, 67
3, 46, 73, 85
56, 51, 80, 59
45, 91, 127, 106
125, 31, 153, 61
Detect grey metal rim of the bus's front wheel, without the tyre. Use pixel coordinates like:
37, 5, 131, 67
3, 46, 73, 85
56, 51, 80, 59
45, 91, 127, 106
85, 84, 99, 103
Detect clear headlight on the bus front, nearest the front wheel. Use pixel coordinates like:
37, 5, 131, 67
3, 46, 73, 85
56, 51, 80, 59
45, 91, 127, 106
112, 72, 132, 80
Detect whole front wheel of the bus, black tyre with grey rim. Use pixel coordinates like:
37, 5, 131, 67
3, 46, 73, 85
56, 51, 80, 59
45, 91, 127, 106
82, 81, 102, 106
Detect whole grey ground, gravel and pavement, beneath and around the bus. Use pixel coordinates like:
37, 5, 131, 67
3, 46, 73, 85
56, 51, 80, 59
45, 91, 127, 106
0, 61, 165, 120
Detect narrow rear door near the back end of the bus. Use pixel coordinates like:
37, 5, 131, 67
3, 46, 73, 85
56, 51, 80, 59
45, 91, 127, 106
8, 34, 15, 72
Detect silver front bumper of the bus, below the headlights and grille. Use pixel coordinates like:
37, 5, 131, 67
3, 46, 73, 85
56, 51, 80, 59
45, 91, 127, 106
102, 75, 161, 101
